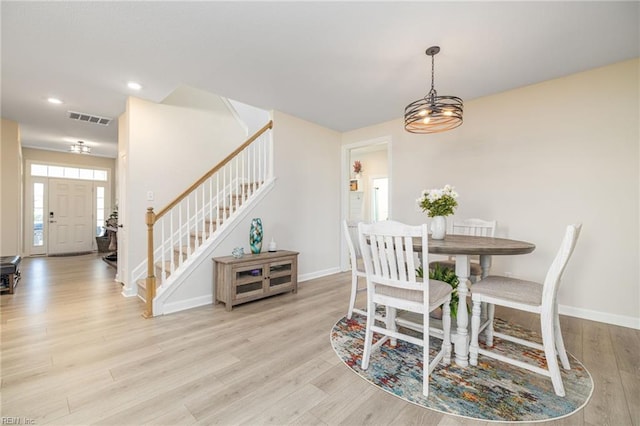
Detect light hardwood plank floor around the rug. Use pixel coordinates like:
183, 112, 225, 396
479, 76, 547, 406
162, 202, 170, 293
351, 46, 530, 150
0, 255, 640, 426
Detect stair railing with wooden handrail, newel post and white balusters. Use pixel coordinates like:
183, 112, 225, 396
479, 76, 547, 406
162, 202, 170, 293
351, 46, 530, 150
142, 121, 273, 318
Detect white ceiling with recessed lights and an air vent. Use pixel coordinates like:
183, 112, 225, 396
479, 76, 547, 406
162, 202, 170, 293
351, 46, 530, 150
0, 1, 640, 157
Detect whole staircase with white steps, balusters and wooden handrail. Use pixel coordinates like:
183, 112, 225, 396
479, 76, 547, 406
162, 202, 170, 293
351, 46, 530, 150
132, 121, 275, 318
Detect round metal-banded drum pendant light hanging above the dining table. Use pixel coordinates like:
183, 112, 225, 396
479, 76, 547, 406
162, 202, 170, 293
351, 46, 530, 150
404, 46, 462, 133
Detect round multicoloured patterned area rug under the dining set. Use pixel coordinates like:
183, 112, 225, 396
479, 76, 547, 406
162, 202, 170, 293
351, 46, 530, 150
331, 314, 593, 422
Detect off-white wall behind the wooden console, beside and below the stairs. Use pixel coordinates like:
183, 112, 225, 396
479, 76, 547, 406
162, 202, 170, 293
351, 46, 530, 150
160, 111, 346, 306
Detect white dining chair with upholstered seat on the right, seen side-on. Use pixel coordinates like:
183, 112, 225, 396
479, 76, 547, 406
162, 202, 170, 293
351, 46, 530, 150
469, 224, 582, 396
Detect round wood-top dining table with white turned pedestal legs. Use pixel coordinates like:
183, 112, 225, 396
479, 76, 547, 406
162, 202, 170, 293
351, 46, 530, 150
413, 234, 536, 367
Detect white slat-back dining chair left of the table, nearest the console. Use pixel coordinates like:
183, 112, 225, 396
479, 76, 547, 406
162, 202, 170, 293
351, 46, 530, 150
358, 221, 452, 396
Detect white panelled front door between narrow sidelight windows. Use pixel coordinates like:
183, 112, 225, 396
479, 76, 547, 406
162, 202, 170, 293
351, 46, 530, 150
47, 179, 95, 254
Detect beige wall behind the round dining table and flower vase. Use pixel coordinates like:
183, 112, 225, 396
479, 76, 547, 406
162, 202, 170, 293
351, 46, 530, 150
343, 59, 640, 328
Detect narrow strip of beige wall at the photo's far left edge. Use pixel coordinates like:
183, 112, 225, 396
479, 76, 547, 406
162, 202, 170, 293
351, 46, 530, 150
0, 118, 23, 256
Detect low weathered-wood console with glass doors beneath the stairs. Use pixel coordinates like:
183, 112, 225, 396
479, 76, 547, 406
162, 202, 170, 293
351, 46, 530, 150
213, 250, 298, 311
